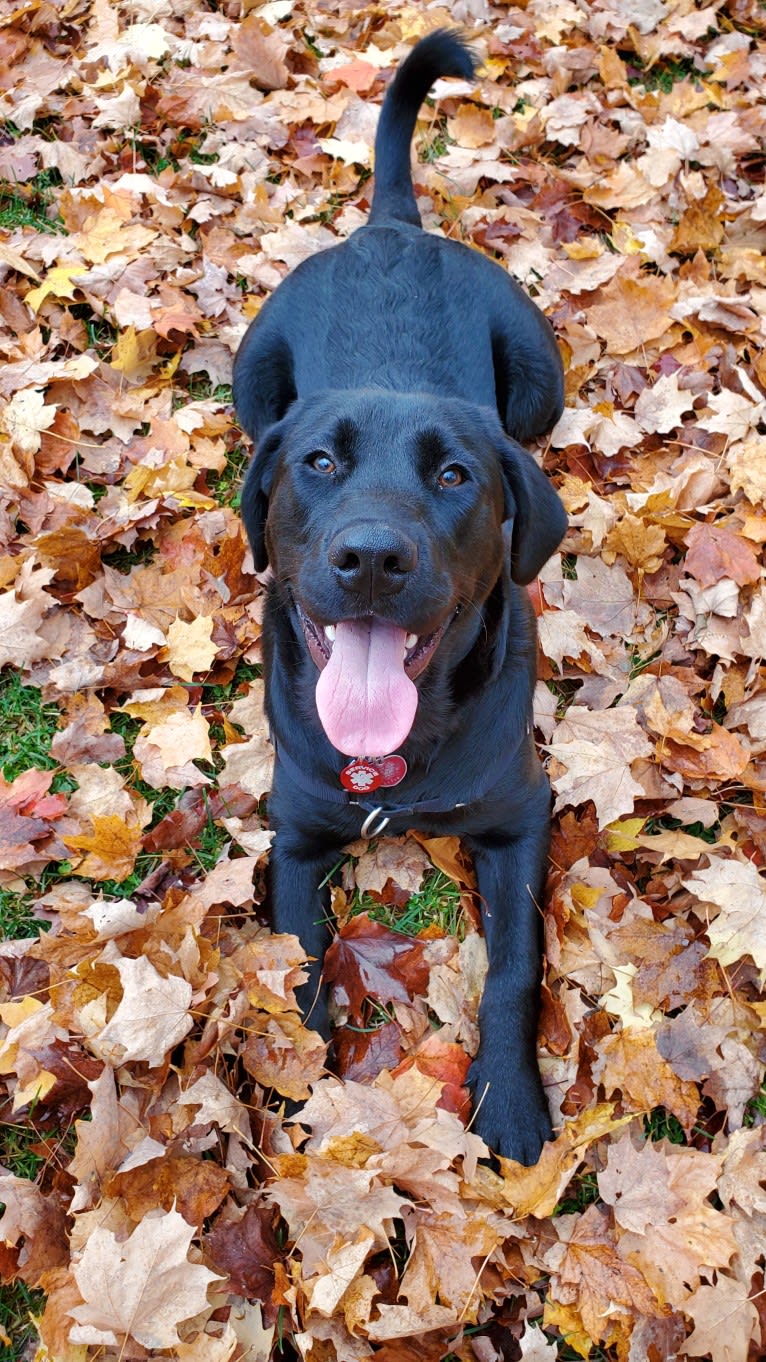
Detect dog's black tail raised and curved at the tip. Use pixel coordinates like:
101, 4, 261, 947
369, 29, 476, 226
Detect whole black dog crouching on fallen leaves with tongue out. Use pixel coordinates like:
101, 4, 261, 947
228, 31, 566, 1163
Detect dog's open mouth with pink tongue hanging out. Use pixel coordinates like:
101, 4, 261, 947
296, 602, 453, 757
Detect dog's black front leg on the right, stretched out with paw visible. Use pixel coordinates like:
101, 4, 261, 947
469, 802, 552, 1165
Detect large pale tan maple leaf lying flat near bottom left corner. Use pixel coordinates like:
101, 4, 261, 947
68, 1211, 219, 1348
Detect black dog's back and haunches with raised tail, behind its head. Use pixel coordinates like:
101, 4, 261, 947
234, 30, 563, 441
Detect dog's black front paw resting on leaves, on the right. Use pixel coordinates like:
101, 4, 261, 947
468, 1056, 553, 1166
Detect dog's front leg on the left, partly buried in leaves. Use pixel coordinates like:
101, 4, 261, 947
269, 829, 341, 1041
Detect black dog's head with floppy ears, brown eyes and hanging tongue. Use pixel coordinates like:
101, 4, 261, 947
243, 391, 566, 756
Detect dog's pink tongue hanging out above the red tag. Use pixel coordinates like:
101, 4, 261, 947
316, 620, 417, 757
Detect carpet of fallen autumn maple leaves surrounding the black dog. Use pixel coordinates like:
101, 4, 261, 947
0, 0, 766, 1362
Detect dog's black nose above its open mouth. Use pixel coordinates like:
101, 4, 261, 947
327, 520, 417, 599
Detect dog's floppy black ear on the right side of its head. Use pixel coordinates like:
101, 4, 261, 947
500, 440, 567, 587
